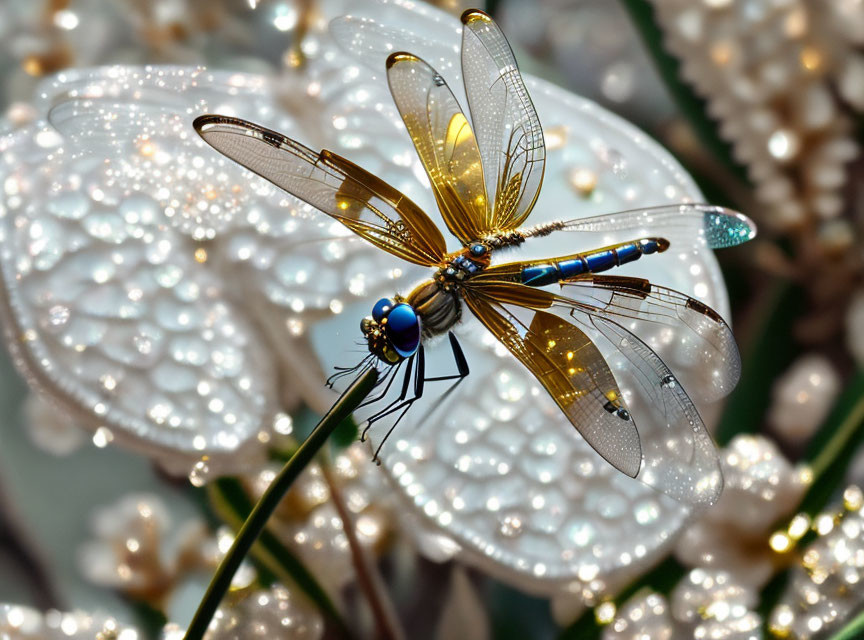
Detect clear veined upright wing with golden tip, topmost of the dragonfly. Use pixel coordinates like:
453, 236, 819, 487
462, 9, 546, 231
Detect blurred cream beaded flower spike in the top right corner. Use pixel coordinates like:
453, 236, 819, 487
652, 0, 864, 229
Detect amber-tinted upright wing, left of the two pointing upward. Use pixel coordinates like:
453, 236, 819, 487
387, 53, 489, 244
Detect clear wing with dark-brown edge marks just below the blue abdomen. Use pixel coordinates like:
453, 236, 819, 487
562, 275, 741, 401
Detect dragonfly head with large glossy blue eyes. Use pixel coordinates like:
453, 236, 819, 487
360, 298, 421, 364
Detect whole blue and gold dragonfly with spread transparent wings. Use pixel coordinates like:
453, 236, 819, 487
194, 9, 756, 504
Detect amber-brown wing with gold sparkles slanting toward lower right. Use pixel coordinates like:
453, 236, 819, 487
465, 285, 642, 478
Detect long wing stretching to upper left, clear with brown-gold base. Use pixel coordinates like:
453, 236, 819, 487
194, 115, 447, 266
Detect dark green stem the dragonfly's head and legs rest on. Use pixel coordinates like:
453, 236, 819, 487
184, 368, 378, 640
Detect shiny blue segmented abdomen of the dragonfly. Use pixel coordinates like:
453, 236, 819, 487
521, 238, 669, 287
